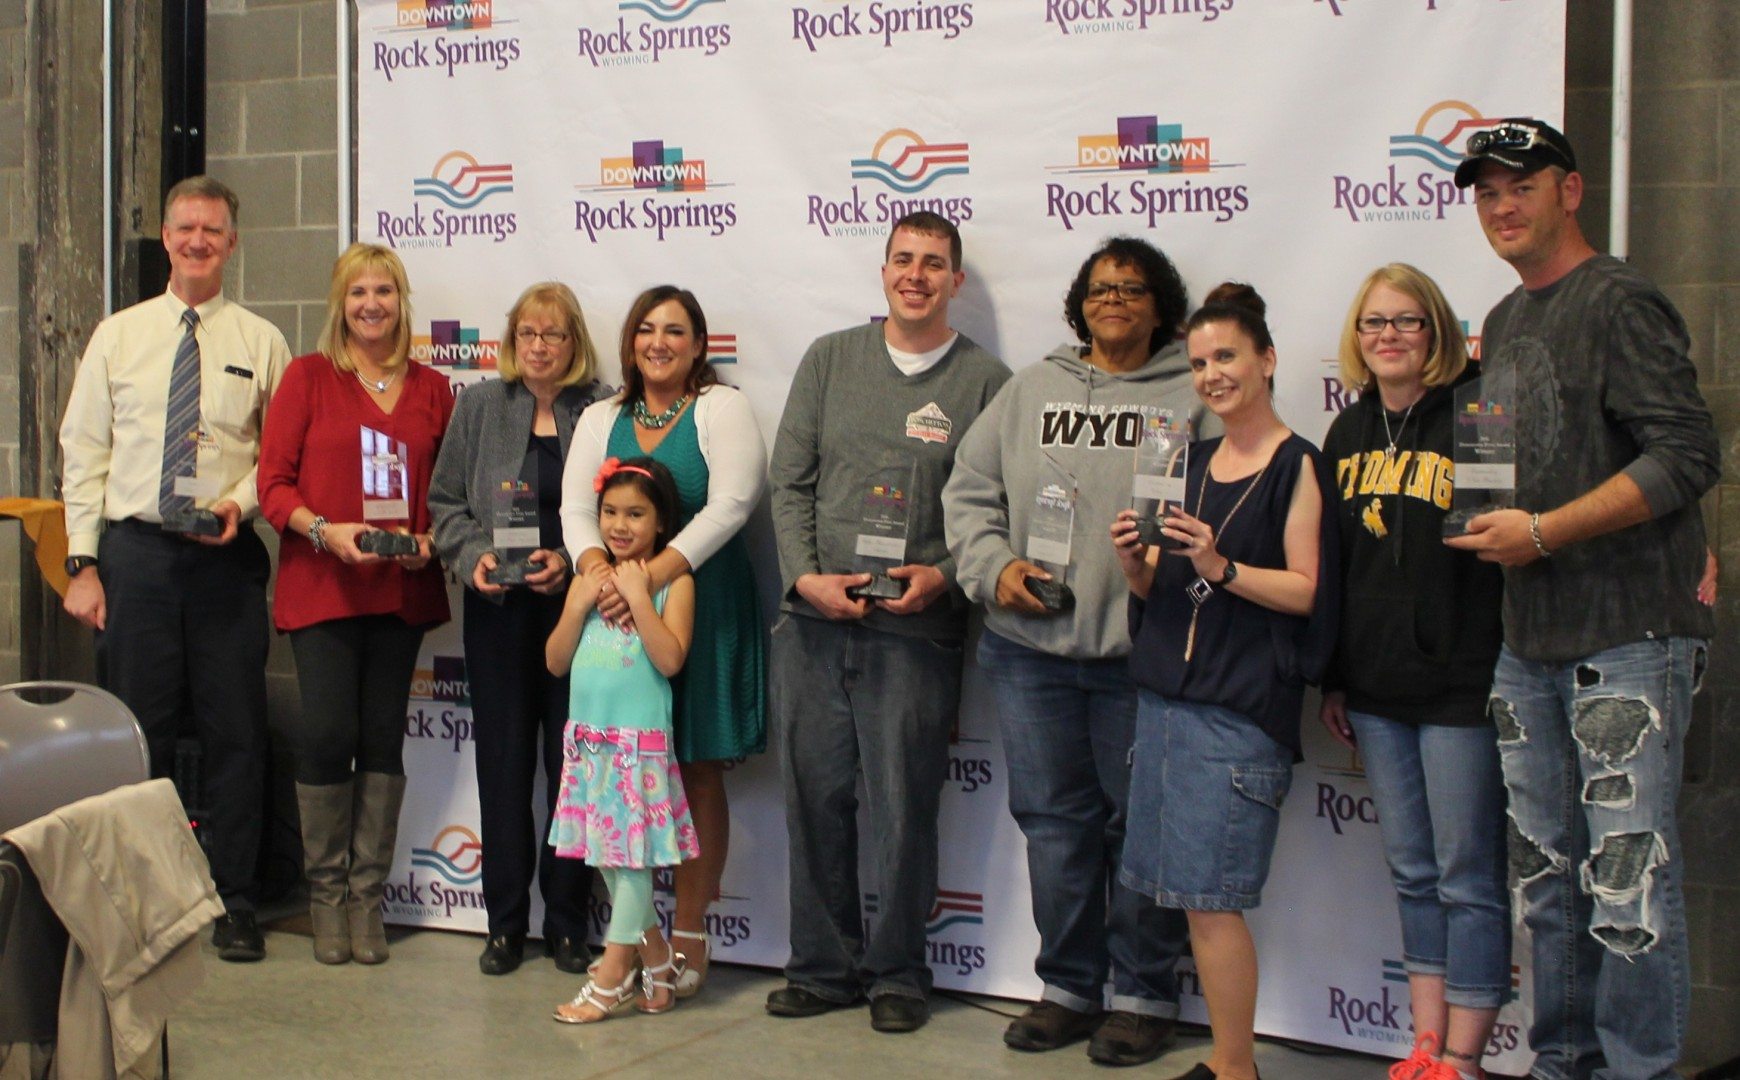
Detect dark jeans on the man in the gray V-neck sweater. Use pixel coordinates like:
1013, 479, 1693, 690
771, 616, 962, 1003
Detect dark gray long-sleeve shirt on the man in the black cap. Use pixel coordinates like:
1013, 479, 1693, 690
1482, 256, 1721, 663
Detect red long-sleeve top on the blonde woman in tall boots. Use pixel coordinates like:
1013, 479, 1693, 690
259, 353, 452, 630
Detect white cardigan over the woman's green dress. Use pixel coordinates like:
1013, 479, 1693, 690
562, 384, 767, 567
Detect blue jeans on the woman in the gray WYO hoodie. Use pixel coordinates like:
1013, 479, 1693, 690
978, 630, 1188, 1017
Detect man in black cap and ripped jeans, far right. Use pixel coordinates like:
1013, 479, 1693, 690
1444, 118, 1721, 1080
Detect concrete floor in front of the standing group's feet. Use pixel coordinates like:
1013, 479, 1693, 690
171, 917, 1412, 1080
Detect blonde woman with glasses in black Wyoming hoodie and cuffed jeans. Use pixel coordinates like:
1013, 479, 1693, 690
1322, 263, 1510, 1080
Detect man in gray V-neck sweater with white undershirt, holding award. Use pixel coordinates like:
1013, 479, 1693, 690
767, 212, 1009, 1031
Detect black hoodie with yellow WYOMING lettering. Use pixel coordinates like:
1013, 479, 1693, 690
1322, 369, 1503, 725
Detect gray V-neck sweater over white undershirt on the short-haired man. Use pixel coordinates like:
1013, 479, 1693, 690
767, 323, 1009, 640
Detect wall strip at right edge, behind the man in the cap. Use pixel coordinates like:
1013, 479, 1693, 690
1566, 0, 1740, 1063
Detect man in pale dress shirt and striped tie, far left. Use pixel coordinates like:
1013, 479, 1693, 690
61, 176, 291, 960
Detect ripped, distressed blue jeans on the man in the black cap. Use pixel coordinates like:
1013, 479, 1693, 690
1491, 638, 1705, 1080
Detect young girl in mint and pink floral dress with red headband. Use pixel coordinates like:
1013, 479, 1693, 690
545, 457, 699, 1024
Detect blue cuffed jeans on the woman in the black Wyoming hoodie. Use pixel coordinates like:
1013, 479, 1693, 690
1347, 711, 1510, 1009
